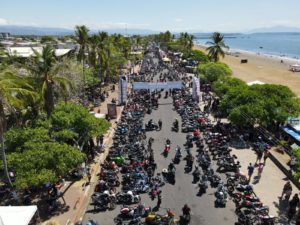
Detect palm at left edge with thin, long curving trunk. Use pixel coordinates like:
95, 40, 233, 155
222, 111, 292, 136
0, 71, 33, 186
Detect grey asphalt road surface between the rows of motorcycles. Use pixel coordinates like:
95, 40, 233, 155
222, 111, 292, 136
84, 87, 236, 225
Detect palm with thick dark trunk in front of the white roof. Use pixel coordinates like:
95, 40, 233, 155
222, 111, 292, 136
29, 45, 72, 117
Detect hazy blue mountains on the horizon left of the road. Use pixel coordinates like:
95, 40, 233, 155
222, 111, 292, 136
0, 25, 158, 36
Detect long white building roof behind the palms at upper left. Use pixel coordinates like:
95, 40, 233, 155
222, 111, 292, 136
6, 47, 71, 58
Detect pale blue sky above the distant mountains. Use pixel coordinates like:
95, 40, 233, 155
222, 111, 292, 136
0, 0, 300, 32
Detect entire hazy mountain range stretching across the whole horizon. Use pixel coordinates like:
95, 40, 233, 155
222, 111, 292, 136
0, 25, 300, 36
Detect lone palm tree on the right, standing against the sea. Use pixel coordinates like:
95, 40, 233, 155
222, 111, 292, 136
206, 32, 229, 62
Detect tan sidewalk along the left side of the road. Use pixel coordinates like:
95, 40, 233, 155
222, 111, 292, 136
42, 85, 122, 225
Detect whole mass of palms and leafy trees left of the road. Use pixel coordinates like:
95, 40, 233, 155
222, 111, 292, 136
0, 26, 142, 189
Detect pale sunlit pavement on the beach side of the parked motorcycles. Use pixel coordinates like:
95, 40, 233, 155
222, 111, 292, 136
199, 102, 299, 224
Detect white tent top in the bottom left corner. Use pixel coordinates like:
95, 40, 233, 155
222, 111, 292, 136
0, 205, 37, 225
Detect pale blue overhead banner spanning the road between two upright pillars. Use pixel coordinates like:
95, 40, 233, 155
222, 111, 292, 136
133, 81, 182, 90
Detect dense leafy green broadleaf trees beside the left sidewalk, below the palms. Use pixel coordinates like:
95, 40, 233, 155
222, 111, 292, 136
6, 103, 110, 189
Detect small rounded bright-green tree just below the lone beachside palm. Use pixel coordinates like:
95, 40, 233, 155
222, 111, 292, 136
197, 62, 232, 82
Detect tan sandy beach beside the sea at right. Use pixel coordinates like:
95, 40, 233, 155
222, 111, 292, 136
195, 45, 300, 97
